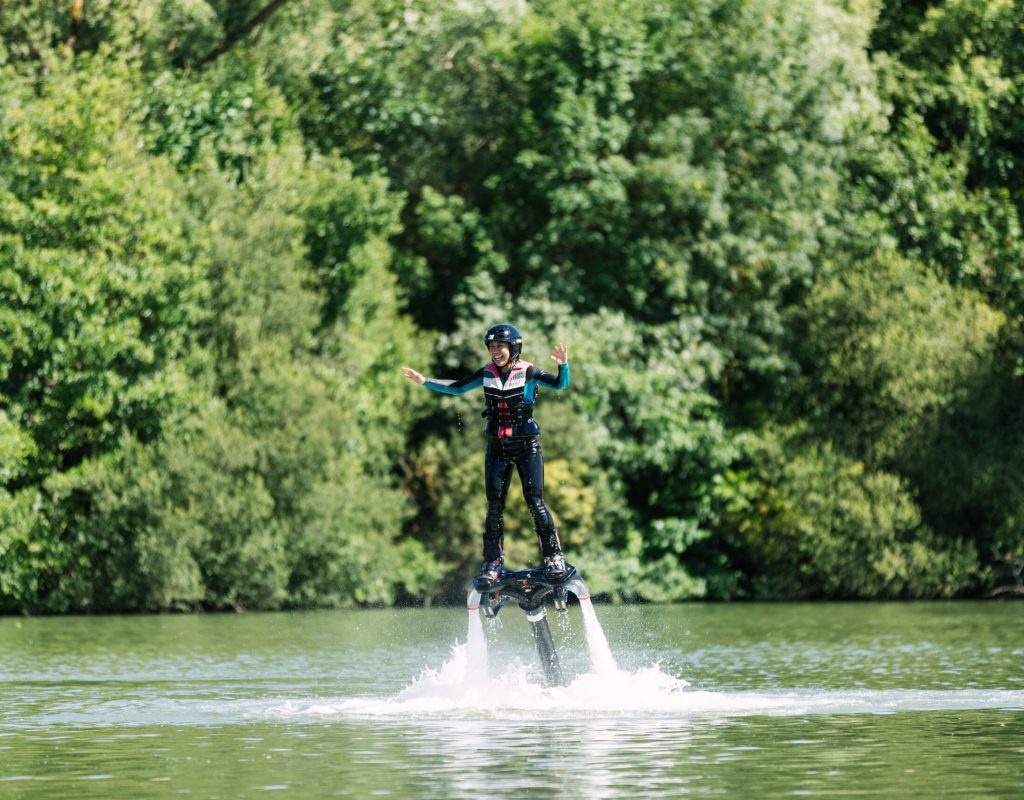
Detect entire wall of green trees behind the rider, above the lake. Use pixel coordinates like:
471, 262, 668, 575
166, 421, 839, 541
0, 0, 1024, 613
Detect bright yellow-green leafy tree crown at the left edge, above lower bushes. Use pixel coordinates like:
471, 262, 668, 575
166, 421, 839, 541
0, 51, 207, 480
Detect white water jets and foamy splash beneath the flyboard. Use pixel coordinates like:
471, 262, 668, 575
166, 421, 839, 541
259, 596, 1024, 720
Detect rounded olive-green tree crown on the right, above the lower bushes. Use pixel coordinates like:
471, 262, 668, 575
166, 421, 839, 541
805, 255, 1006, 468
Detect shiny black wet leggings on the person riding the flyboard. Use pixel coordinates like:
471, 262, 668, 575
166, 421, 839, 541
483, 436, 561, 561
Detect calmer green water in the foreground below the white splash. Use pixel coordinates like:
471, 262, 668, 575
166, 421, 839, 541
0, 711, 1024, 799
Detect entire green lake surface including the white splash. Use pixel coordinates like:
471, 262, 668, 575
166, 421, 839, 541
0, 602, 1024, 800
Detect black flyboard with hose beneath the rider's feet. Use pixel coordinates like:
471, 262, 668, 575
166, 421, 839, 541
466, 563, 590, 686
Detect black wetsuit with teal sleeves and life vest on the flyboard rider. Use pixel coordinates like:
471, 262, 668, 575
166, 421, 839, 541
424, 361, 569, 561
